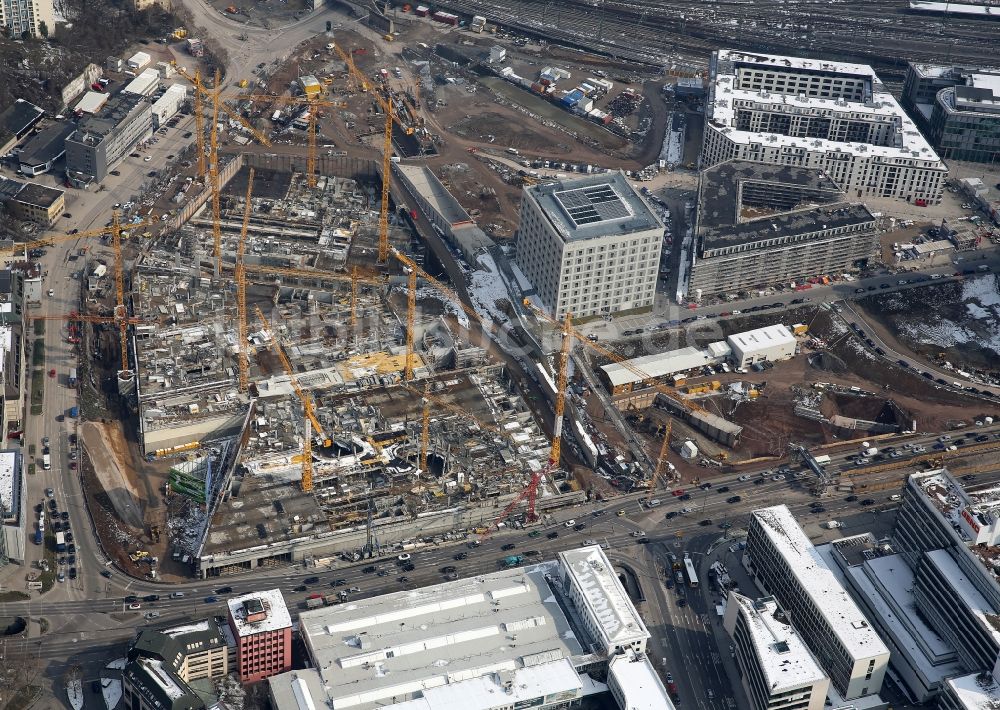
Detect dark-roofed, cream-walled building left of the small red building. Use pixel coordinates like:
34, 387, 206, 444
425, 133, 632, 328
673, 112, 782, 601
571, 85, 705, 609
122, 617, 236, 710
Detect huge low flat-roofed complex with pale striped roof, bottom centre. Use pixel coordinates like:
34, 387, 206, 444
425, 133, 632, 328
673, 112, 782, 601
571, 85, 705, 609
268, 546, 673, 710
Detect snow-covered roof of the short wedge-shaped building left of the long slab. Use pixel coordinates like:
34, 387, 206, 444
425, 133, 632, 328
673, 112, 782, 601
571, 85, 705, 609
728, 592, 826, 695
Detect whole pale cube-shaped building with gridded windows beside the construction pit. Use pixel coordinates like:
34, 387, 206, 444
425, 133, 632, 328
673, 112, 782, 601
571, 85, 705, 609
517, 172, 663, 318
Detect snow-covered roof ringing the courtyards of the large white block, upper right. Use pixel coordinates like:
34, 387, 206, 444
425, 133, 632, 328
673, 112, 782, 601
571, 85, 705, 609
706, 49, 944, 169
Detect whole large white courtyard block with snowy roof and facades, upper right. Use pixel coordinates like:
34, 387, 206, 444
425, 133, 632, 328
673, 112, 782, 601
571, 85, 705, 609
702, 50, 948, 205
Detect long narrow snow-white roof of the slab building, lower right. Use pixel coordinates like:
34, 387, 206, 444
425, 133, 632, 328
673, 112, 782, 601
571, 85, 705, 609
753, 505, 889, 659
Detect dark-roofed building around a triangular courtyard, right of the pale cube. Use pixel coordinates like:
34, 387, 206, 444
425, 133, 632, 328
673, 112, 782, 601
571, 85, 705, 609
682, 161, 879, 300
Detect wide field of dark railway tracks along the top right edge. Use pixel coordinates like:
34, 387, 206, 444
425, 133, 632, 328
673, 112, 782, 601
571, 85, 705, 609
439, 0, 996, 71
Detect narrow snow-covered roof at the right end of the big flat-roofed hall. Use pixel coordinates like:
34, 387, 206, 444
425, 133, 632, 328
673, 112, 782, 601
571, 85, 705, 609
559, 545, 649, 652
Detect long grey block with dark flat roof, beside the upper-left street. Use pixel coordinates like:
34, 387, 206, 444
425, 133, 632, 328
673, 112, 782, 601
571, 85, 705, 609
66, 92, 153, 187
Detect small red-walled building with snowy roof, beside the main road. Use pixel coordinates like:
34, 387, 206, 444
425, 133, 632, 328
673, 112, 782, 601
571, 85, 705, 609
228, 589, 292, 683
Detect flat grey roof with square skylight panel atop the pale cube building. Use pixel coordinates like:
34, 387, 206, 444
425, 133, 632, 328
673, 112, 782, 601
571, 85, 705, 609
525, 172, 663, 241
